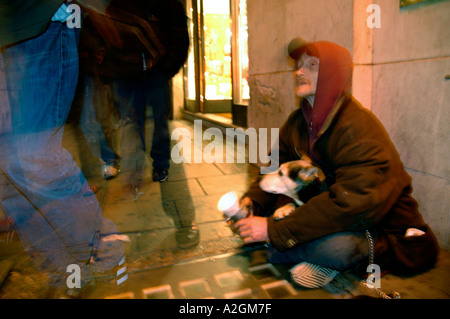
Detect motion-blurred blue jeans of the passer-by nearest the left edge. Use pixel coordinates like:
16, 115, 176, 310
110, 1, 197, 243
0, 22, 123, 284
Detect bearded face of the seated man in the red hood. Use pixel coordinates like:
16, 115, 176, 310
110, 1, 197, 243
294, 52, 319, 97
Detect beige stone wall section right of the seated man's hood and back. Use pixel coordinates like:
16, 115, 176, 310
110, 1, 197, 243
354, 0, 450, 249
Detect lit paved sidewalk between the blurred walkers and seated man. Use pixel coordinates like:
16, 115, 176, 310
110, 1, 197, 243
0, 121, 450, 299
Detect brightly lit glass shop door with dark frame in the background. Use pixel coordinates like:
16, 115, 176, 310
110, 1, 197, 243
184, 0, 249, 122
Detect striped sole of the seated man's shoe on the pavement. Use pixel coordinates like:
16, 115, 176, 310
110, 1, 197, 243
290, 262, 339, 288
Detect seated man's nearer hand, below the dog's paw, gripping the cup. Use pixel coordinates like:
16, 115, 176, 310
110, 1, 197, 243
233, 216, 269, 244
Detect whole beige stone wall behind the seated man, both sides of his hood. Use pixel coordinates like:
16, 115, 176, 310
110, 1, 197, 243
247, 0, 450, 249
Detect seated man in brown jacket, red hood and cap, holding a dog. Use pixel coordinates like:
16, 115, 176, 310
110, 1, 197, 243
233, 38, 439, 288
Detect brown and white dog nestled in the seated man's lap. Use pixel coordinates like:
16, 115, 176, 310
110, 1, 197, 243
259, 155, 325, 219
